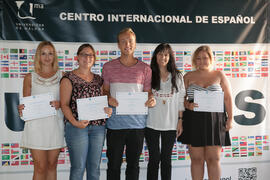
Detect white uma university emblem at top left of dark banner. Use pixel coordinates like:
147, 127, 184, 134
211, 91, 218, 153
15, 1, 44, 19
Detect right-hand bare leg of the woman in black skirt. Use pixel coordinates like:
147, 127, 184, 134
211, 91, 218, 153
205, 146, 221, 180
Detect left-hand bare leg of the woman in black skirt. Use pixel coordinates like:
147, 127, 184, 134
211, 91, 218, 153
188, 145, 205, 180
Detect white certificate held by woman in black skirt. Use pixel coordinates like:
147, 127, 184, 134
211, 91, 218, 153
194, 91, 224, 112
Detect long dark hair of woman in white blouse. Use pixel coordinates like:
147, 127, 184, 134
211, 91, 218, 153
150, 43, 182, 92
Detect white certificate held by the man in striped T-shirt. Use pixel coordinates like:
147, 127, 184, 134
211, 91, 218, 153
116, 92, 148, 115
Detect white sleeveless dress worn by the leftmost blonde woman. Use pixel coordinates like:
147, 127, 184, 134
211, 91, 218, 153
20, 71, 66, 150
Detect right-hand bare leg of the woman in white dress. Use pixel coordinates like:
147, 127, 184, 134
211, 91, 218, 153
47, 149, 60, 180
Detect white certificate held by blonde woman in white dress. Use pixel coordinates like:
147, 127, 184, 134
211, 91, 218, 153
20, 93, 56, 121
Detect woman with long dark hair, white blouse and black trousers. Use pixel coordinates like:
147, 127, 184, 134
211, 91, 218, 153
145, 43, 185, 180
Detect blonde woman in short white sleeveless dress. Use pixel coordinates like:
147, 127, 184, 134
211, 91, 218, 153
18, 41, 66, 180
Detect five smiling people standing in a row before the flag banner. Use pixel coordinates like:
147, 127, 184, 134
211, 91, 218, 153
18, 28, 232, 180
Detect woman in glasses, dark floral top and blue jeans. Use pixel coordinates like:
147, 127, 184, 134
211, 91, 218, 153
60, 44, 112, 180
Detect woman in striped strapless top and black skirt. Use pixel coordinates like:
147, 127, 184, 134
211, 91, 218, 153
178, 46, 233, 180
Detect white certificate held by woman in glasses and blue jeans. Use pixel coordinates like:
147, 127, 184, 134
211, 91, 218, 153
76, 96, 108, 121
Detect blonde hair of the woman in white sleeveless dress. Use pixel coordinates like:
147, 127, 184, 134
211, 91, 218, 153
34, 41, 58, 73
